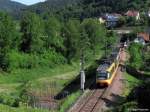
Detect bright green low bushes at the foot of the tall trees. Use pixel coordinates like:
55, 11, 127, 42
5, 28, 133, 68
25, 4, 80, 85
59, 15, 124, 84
8, 50, 66, 71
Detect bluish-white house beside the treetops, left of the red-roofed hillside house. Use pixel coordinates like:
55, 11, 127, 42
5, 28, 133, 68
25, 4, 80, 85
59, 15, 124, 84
104, 13, 121, 28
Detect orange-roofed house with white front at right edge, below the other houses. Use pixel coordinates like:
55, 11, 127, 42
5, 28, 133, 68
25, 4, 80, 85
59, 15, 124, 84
134, 33, 150, 45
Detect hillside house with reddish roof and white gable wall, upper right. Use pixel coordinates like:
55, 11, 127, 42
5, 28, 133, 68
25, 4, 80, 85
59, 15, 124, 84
125, 10, 140, 20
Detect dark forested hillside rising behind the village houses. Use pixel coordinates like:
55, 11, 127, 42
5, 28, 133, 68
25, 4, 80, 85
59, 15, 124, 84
26, 0, 150, 19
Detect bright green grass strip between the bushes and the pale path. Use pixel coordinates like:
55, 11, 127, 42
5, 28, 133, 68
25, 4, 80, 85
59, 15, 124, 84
0, 63, 78, 84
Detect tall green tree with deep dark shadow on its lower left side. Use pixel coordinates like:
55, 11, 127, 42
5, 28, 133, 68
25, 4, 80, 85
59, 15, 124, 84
21, 12, 44, 53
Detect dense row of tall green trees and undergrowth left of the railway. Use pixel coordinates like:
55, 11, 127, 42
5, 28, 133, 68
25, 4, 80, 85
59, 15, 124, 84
0, 12, 114, 71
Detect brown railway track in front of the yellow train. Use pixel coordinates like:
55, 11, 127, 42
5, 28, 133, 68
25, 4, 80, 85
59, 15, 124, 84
69, 67, 120, 112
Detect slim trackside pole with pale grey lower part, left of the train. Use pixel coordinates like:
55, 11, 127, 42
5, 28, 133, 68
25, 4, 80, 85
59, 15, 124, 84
80, 49, 85, 91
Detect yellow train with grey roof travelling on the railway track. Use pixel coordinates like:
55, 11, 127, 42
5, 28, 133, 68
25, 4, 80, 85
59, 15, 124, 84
96, 48, 122, 87
